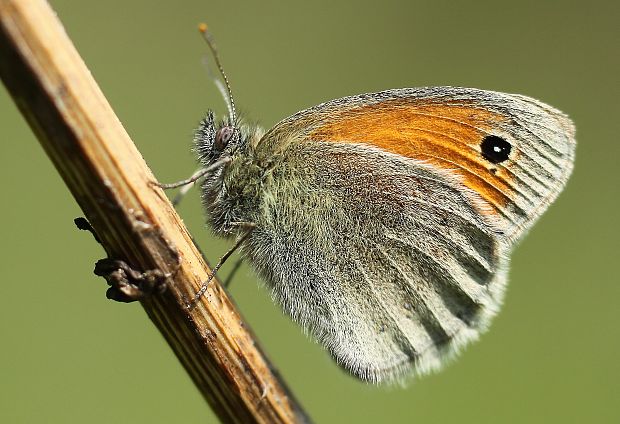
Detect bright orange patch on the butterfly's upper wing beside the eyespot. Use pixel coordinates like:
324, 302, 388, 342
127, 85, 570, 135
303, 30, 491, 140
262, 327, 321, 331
307, 100, 513, 219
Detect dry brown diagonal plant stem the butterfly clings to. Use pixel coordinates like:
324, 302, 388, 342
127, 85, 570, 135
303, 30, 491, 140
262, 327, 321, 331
0, 0, 306, 423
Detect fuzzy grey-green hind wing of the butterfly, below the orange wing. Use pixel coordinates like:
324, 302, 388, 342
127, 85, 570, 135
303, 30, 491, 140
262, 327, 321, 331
244, 142, 506, 382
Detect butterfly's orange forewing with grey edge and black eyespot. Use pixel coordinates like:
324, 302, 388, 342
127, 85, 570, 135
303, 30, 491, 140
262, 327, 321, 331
264, 87, 575, 242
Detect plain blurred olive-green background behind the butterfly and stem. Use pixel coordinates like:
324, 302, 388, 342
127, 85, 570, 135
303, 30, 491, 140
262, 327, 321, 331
0, 0, 620, 424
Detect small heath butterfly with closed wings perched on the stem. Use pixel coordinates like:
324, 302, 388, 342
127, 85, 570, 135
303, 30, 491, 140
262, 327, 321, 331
177, 27, 575, 383
